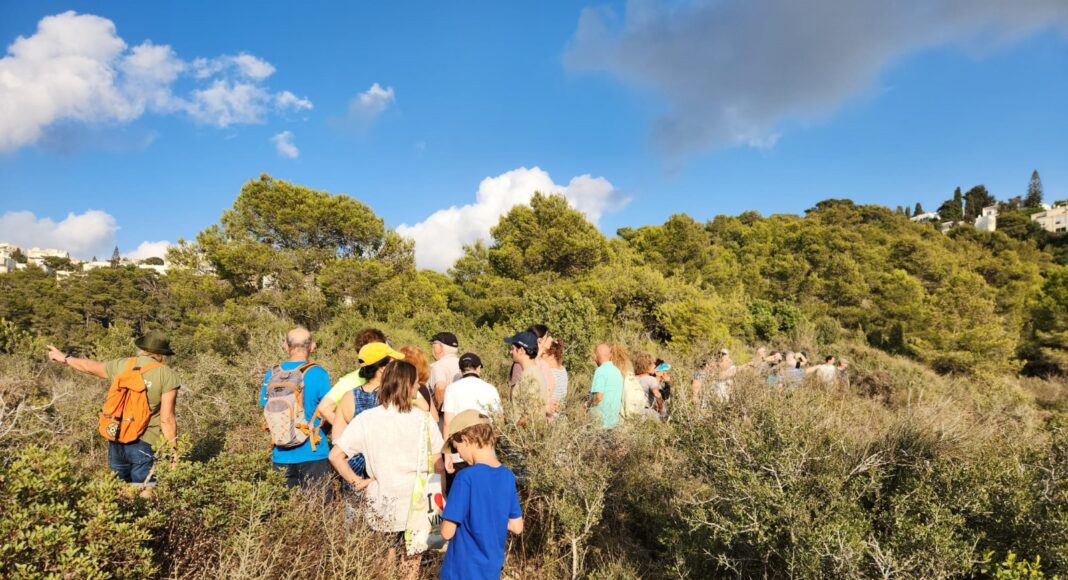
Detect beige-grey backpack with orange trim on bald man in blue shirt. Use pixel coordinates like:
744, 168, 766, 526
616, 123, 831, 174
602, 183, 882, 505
264, 362, 319, 451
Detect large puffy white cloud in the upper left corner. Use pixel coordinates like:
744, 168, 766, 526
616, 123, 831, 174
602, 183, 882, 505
0, 12, 312, 153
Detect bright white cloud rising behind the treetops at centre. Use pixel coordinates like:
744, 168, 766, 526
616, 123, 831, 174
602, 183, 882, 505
397, 167, 629, 271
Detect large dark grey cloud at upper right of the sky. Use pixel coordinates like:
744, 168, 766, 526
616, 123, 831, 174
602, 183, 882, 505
564, 0, 1068, 156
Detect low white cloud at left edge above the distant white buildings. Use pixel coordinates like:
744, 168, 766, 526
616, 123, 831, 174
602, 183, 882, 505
0, 209, 119, 260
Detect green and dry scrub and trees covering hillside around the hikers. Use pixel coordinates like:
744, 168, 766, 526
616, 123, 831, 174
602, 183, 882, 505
0, 176, 1068, 578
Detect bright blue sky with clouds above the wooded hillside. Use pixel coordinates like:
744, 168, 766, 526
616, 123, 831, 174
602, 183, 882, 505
0, 0, 1068, 268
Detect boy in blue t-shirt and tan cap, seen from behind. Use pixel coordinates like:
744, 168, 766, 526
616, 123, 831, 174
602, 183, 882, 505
441, 410, 523, 580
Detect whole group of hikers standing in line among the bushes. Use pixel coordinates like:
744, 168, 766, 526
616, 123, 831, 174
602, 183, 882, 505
48, 325, 847, 578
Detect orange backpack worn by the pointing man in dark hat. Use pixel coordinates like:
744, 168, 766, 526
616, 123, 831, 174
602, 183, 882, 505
100, 358, 162, 443
